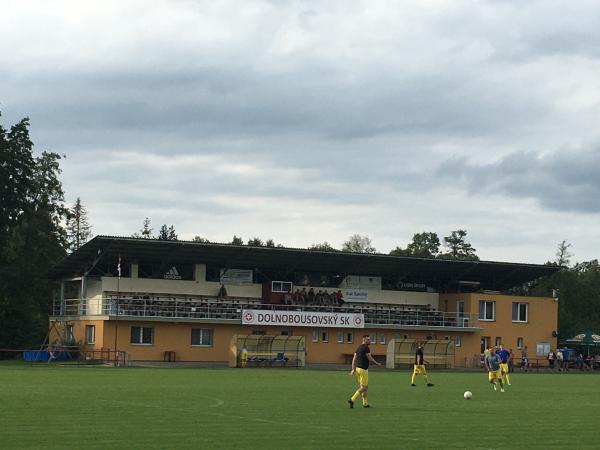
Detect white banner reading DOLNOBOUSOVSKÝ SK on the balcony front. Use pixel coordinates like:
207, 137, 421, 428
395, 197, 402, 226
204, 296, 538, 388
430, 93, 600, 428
242, 309, 365, 328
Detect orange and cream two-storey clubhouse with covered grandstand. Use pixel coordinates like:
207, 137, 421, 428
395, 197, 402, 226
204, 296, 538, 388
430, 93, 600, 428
50, 236, 558, 367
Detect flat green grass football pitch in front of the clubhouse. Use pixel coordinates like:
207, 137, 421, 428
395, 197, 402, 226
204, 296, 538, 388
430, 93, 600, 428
0, 363, 600, 449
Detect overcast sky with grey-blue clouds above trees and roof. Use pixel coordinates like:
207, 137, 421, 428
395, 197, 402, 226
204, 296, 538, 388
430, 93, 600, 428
0, 0, 600, 263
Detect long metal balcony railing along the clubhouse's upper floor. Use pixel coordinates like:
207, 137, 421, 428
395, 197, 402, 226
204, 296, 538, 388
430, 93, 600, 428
54, 296, 477, 328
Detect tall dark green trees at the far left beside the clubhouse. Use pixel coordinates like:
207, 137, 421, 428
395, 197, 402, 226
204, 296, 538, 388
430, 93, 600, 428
0, 113, 67, 348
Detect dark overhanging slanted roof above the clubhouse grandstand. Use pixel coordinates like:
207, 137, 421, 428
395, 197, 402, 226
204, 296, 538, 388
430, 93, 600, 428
49, 236, 559, 291
